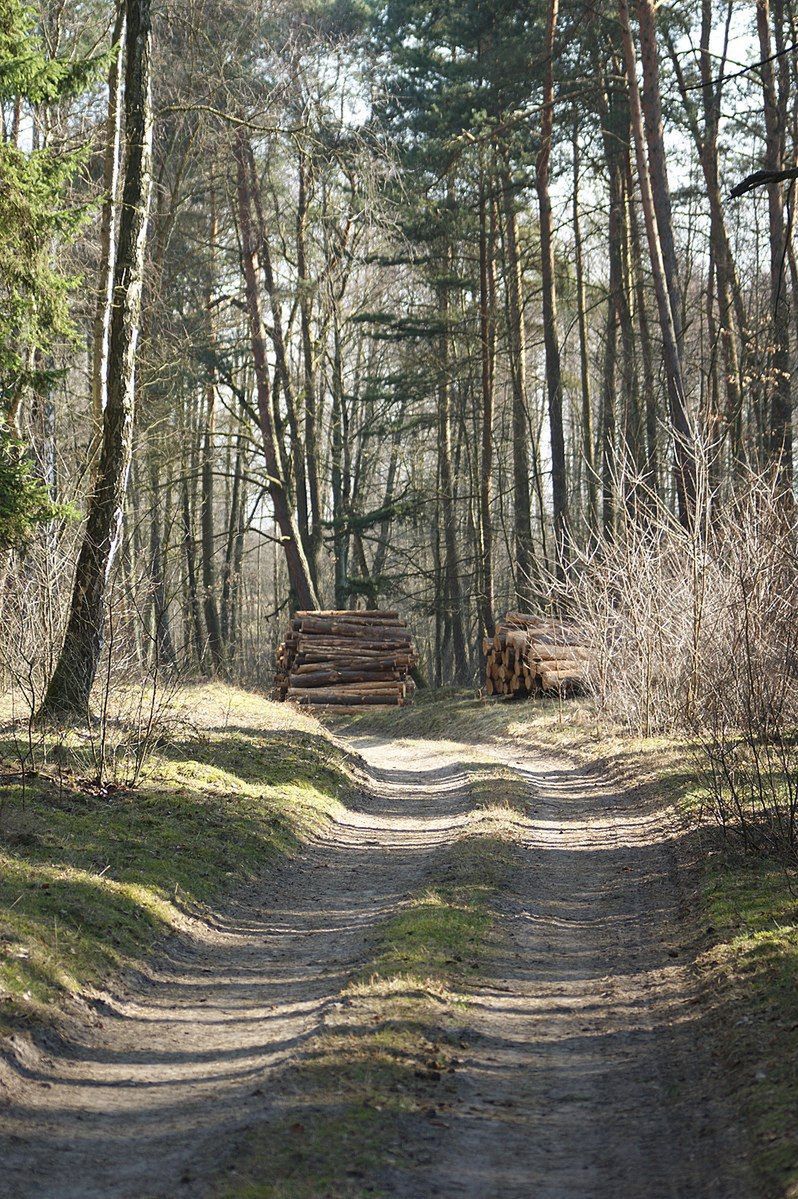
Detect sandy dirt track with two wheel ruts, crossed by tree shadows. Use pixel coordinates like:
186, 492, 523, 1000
0, 737, 751, 1199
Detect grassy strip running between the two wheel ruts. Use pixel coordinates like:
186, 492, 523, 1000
217, 800, 519, 1199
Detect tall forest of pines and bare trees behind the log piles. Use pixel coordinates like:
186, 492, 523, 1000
0, 0, 798, 712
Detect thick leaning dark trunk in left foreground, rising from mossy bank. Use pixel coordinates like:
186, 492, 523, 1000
42, 0, 152, 716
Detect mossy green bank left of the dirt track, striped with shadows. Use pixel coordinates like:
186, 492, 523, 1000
0, 687, 352, 1034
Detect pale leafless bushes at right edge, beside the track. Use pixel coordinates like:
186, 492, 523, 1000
566, 477, 798, 854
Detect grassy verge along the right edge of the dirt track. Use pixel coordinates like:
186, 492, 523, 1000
337, 692, 798, 1199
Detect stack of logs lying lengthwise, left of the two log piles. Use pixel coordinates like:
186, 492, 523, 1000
274, 610, 417, 706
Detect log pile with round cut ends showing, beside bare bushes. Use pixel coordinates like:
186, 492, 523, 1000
482, 611, 590, 699
